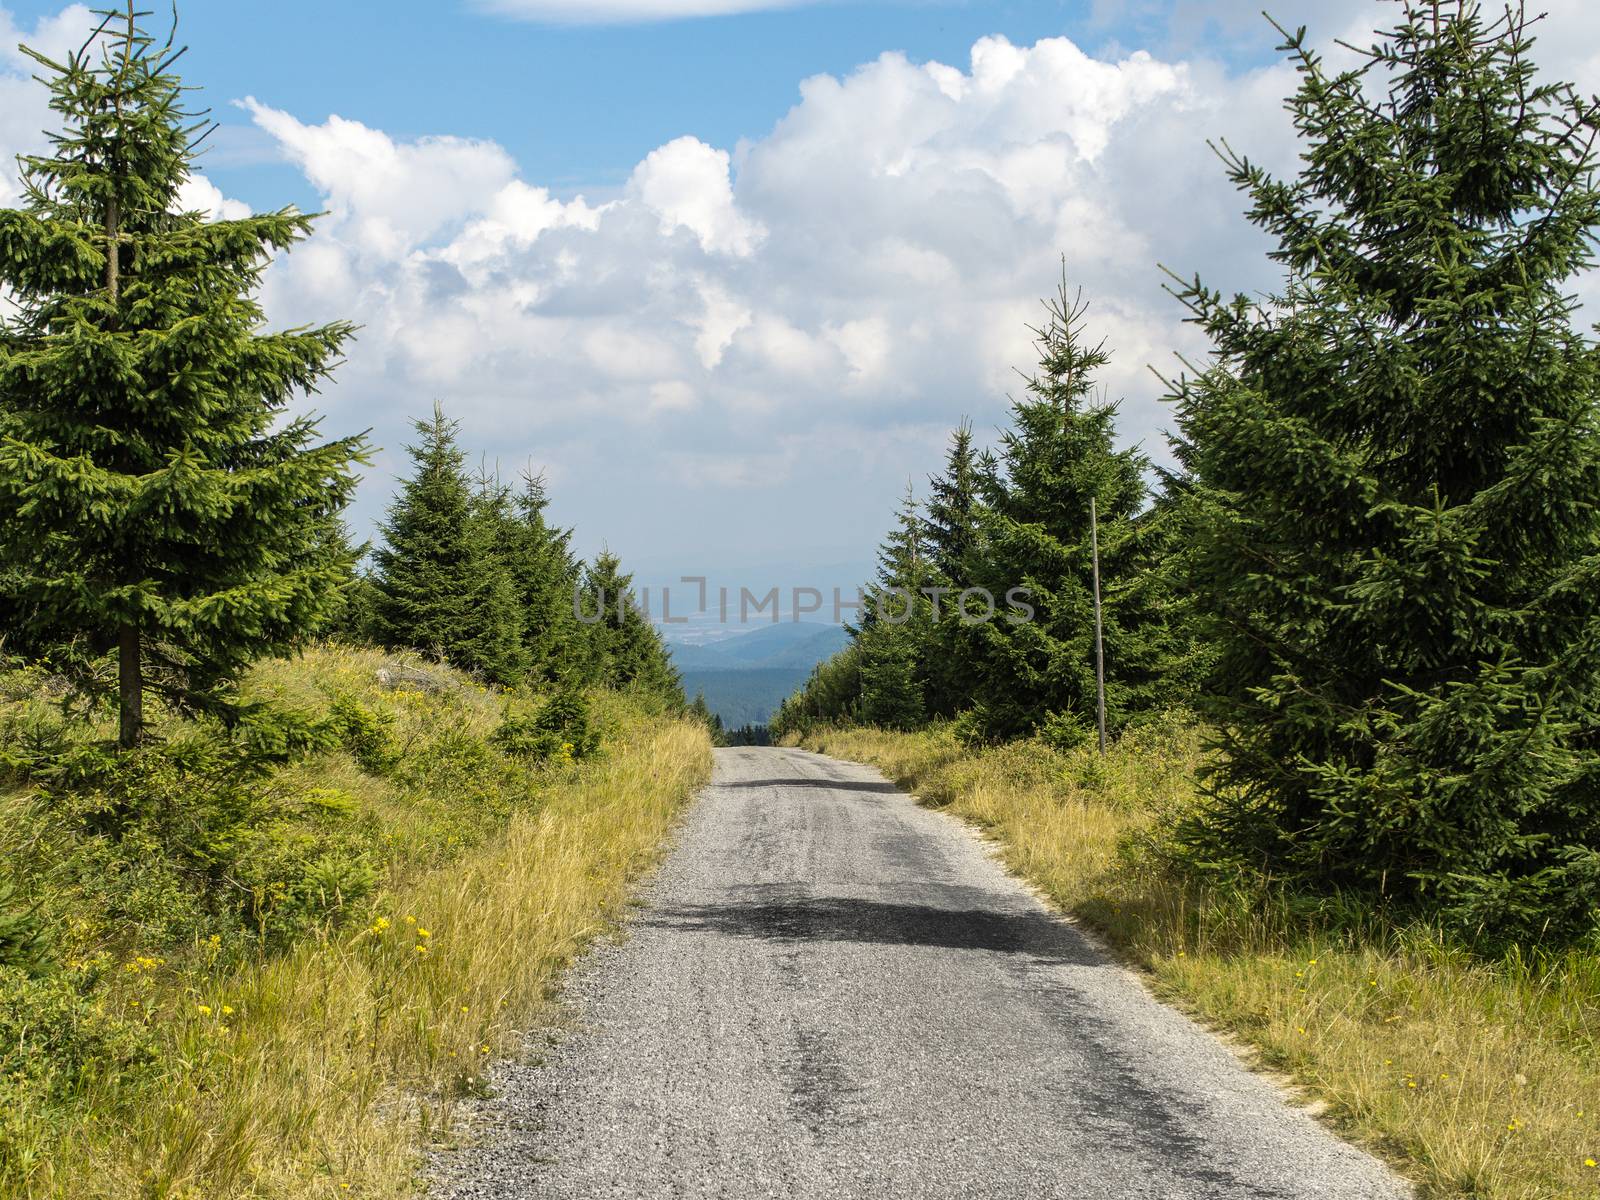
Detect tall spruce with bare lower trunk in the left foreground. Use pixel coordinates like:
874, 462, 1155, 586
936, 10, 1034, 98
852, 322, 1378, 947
0, 3, 362, 746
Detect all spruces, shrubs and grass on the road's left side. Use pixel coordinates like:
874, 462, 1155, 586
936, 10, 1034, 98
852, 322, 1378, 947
0, 5, 710, 1200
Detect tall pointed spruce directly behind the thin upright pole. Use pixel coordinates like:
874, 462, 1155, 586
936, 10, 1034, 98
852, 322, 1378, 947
952, 278, 1163, 738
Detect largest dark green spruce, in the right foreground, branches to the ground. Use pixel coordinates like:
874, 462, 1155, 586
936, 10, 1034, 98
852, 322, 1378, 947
1176, 2, 1600, 938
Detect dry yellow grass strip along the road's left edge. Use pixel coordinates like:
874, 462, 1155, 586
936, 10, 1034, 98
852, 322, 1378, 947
10, 656, 710, 1200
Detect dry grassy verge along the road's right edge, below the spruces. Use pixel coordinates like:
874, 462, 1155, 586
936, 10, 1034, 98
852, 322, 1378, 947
805, 725, 1600, 1200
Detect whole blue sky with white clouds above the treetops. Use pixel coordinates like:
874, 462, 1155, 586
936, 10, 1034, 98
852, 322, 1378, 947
0, 0, 1600, 601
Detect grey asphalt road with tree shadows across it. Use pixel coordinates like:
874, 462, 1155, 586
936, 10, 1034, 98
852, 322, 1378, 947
435, 749, 1410, 1200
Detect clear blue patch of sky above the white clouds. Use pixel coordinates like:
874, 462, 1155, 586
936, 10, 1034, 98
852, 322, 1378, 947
5, 0, 1274, 206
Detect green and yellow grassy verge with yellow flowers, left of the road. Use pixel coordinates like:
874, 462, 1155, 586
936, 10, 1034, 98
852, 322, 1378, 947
0, 650, 710, 1200
